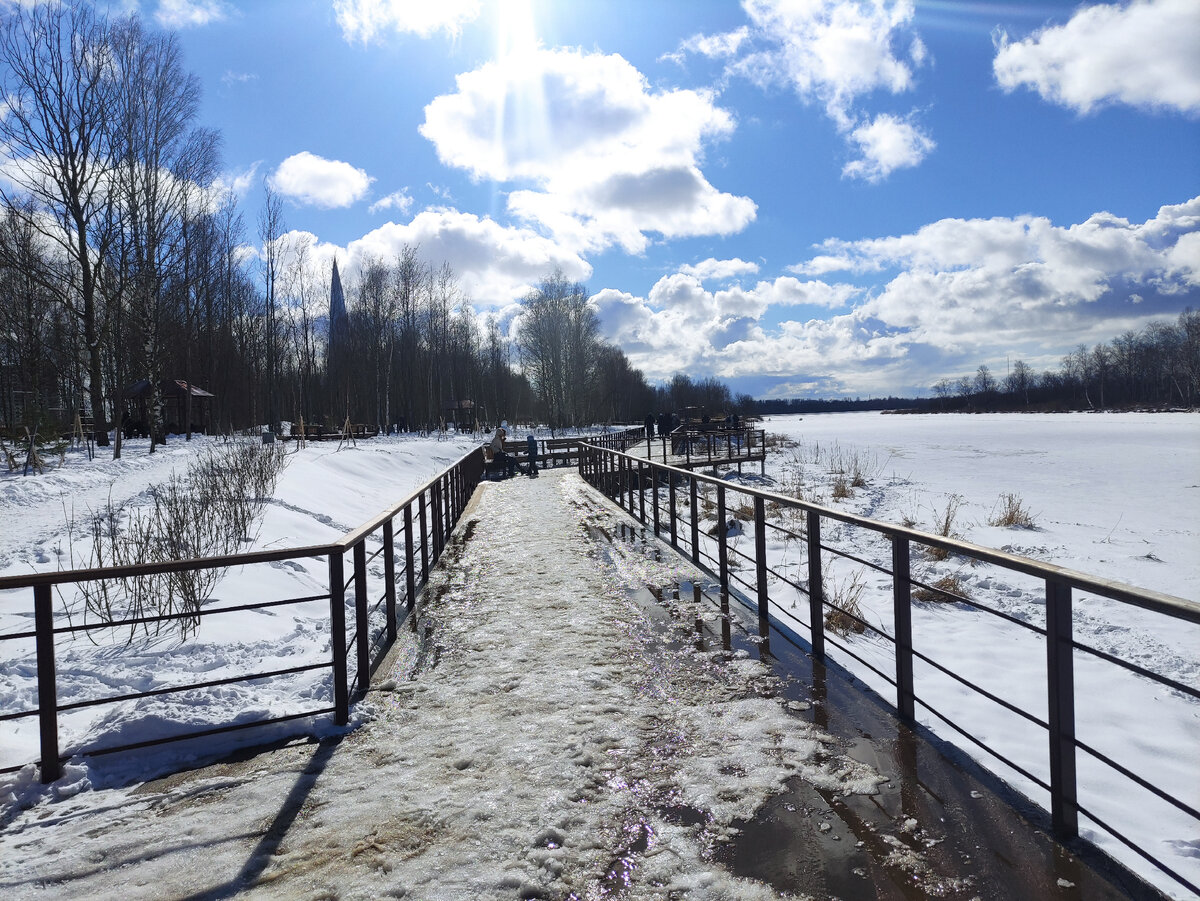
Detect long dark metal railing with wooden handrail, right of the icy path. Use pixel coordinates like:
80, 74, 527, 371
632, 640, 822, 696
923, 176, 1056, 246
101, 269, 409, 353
580, 438, 1200, 893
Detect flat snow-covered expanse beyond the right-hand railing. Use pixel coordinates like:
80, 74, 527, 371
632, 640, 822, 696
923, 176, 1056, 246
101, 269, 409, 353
700, 413, 1200, 897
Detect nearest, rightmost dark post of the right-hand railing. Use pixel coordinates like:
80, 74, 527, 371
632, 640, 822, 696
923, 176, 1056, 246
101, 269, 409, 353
1046, 579, 1079, 839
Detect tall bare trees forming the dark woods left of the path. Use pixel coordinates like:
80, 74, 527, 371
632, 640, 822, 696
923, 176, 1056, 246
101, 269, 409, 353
0, 4, 748, 457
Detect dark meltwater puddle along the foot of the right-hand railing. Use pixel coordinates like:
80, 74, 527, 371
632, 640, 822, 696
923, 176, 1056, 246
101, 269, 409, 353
589, 523, 1158, 900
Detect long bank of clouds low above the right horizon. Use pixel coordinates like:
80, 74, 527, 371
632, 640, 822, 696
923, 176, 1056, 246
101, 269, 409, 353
592, 197, 1200, 394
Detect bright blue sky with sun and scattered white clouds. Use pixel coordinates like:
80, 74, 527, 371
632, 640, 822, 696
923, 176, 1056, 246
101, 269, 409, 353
116, 0, 1200, 396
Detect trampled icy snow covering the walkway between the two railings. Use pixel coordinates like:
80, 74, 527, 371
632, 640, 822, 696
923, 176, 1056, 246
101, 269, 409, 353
0, 473, 881, 899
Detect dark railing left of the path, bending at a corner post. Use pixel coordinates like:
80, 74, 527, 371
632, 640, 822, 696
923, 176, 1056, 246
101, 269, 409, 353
0, 449, 484, 782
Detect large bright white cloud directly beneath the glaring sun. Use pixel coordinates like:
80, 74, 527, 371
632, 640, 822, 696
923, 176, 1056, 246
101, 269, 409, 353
420, 49, 756, 253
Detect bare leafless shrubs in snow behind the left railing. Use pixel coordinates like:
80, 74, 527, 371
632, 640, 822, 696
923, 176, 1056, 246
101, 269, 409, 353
72, 443, 287, 641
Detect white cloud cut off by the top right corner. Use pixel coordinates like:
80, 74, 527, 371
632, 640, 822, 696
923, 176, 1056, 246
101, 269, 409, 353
994, 0, 1200, 114
